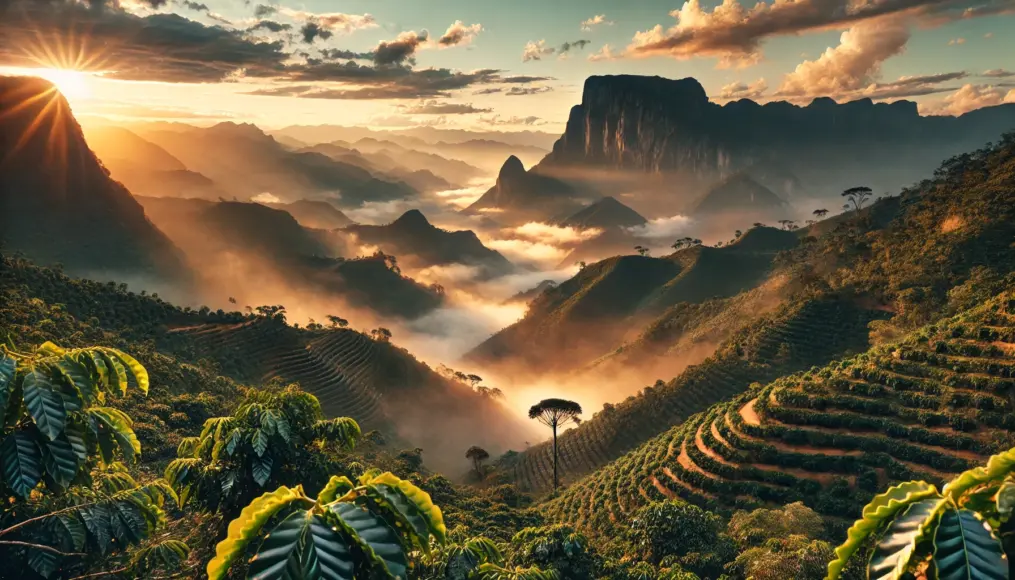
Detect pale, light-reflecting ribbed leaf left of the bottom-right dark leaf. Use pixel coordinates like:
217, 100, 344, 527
867, 499, 945, 580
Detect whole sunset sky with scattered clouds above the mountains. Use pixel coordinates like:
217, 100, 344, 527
0, 0, 1015, 133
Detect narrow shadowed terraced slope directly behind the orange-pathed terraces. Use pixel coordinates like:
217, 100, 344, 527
513, 296, 885, 491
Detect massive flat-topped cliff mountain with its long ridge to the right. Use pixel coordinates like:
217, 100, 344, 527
537, 75, 1015, 197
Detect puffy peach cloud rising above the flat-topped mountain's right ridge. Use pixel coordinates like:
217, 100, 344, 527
776, 18, 909, 96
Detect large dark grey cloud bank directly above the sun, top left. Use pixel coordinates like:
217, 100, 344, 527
0, 0, 289, 82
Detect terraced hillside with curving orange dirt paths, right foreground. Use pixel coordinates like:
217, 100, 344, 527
551, 287, 1015, 531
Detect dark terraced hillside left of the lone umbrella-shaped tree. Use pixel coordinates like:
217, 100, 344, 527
164, 317, 529, 469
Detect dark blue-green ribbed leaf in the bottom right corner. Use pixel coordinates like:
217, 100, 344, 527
934, 510, 1008, 580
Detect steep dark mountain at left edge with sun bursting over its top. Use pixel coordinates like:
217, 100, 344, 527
0, 76, 186, 279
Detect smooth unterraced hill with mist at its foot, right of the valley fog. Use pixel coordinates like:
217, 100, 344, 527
467, 228, 798, 372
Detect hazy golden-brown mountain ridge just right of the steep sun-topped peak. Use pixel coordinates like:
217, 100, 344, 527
142, 123, 416, 207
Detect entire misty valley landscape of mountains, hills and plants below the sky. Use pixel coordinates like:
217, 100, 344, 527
0, 40, 1015, 580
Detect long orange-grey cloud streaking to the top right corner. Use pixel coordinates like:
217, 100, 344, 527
625, 0, 1015, 67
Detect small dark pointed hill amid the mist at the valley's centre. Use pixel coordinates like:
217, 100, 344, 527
344, 209, 512, 275
